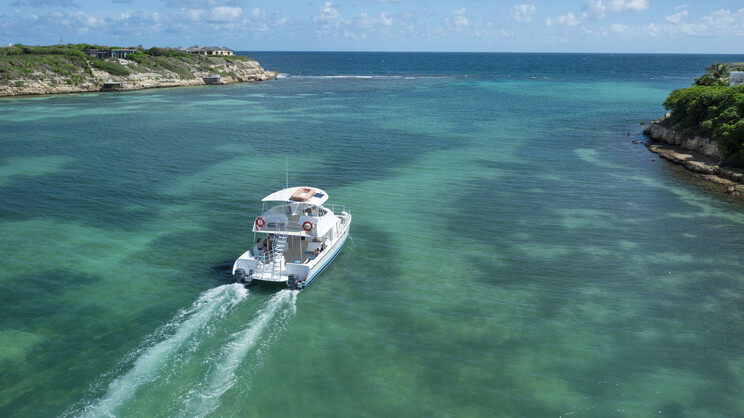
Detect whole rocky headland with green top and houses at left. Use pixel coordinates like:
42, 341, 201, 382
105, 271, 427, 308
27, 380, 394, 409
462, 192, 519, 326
0, 44, 278, 96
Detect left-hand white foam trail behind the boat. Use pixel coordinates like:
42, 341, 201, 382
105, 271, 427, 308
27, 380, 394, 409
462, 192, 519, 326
77, 283, 248, 417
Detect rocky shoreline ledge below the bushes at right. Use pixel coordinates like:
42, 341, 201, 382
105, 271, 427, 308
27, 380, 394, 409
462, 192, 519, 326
643, 114, 744, 196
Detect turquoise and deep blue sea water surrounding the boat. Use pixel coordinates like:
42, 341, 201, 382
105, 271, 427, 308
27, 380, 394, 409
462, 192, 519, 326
0, 53, 744, 416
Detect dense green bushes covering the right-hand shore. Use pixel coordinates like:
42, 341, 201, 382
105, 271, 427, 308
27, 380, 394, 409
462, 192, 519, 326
664, 63, 744, 167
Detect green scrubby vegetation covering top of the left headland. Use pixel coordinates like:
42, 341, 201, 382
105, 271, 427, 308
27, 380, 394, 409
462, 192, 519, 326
0, 44, 253, 87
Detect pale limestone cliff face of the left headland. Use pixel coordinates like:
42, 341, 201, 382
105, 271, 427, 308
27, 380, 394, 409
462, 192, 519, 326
0, 59, 278, 96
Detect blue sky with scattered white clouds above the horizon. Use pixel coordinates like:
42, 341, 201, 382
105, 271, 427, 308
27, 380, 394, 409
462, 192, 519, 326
0, 0, 744, 54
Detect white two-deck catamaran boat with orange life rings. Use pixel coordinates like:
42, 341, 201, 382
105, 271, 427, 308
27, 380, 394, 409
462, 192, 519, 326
233, 187, 351, 290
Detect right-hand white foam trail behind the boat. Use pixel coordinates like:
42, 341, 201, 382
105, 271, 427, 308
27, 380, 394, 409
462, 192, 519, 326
182, 289, 299, 416
